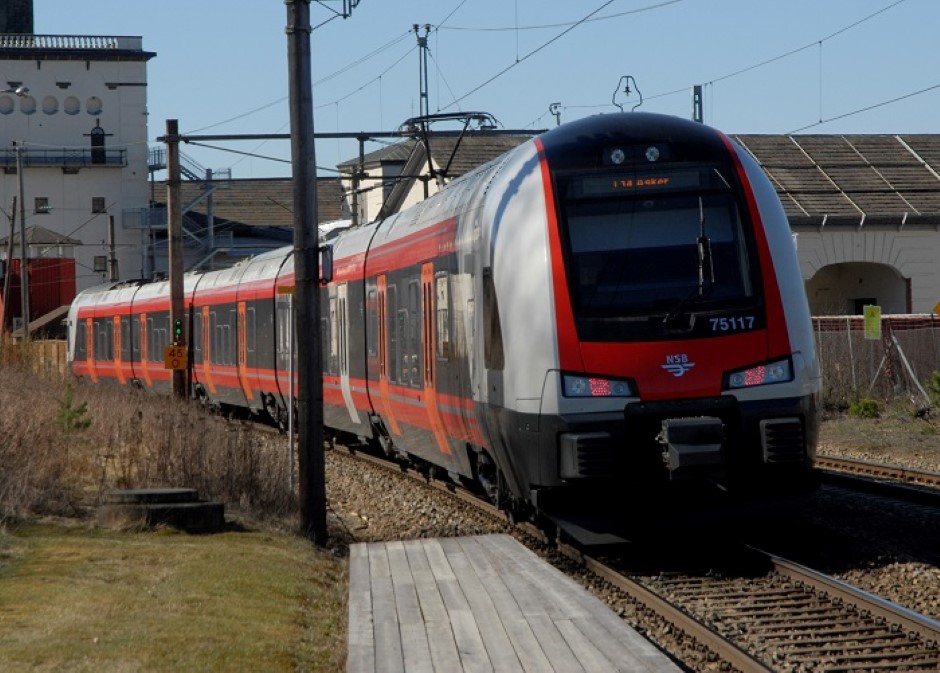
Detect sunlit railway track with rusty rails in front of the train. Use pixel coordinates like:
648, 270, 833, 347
338, 444, 940, 673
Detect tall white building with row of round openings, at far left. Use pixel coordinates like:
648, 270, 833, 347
0, 34, 156, 304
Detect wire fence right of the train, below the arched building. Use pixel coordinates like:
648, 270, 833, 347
813, 314, 940, 408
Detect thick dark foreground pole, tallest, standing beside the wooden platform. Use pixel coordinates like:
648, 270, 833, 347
284, 0, 327, 546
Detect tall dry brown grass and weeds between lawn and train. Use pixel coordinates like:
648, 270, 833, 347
0, 365, 297, 525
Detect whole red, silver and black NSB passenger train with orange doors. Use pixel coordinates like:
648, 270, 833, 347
68, 112, 820, 516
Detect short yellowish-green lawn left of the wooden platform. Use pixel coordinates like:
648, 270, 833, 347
0, 523, 346, 672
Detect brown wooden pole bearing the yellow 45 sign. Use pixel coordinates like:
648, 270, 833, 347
164, 119, 187, 397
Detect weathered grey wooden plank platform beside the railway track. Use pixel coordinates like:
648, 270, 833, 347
346, 535, 681, 673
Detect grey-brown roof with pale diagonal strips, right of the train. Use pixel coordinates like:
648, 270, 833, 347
732, 135, 940, 227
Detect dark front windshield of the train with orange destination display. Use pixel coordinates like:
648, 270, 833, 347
562, 168, 763, 341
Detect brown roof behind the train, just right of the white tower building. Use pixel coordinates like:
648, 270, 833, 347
174, 178, 349, 227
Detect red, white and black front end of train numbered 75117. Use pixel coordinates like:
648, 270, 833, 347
530, 113, 819, 510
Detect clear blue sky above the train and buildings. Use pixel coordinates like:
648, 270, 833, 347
34, 0, 940, 178
